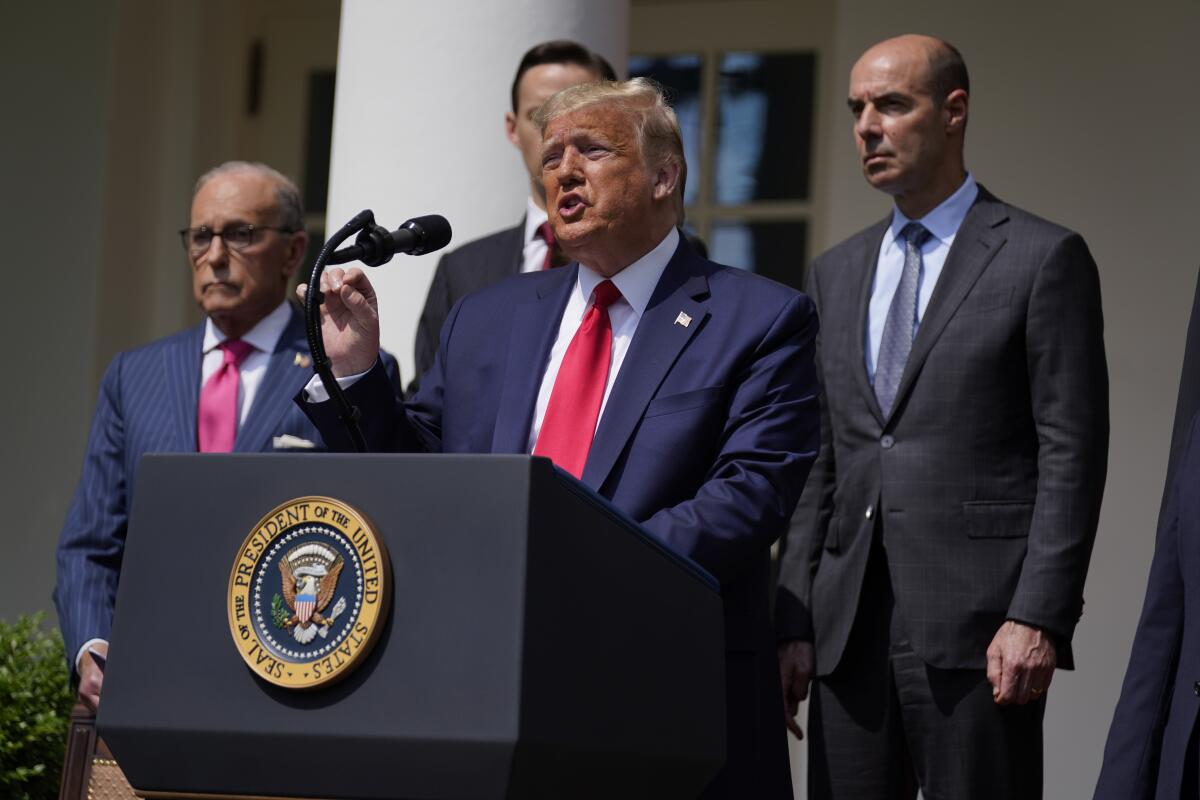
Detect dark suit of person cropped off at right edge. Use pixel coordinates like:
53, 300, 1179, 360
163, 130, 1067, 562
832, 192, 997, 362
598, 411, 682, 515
1096, 416, 1200, 800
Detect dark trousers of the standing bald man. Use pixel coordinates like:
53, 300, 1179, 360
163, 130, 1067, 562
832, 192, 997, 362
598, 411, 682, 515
808, 540, 1045, 800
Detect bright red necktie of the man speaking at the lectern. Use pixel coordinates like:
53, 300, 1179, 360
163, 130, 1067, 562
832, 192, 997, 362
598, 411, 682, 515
533, 281, 620, 477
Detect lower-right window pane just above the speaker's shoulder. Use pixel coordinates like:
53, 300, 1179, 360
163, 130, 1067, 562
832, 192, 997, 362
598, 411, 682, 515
708, 221, 809, 289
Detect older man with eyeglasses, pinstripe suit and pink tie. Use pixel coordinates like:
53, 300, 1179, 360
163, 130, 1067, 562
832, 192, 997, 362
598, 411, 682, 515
54, 161, 398, 710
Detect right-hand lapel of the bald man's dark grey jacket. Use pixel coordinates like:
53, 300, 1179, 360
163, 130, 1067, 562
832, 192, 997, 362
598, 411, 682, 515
892, 186, 1008, 424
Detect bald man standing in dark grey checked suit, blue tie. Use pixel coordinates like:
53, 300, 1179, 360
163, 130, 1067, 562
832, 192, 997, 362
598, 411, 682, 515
775, 36, 1109, 800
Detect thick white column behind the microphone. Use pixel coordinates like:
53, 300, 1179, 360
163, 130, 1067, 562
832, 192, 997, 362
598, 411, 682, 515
326, 0, 629, 383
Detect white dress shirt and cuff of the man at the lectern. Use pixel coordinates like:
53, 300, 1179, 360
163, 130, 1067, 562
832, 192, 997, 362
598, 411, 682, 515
305, 227, 679, 452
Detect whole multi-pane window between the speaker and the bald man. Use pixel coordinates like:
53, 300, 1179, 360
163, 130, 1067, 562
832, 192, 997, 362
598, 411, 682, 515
630, 52, 816, 288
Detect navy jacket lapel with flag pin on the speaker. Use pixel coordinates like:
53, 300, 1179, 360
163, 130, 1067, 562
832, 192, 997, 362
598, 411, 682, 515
582, 242, 708, 492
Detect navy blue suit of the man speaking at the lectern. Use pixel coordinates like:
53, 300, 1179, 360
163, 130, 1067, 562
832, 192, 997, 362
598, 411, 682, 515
306, 236, 818, 798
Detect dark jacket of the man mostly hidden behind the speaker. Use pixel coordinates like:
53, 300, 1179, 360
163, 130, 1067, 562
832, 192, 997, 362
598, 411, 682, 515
408, 217, 524, 395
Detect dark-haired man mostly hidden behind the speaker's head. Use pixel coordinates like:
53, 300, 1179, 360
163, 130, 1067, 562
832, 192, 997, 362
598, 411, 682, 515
409, 40, 617, 393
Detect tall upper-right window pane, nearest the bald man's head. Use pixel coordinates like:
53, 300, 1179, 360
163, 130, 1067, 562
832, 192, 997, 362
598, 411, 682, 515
715, 53, 815, 205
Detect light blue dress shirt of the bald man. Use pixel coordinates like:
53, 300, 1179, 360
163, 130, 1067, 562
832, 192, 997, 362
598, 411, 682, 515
864, 173, 979, 383
